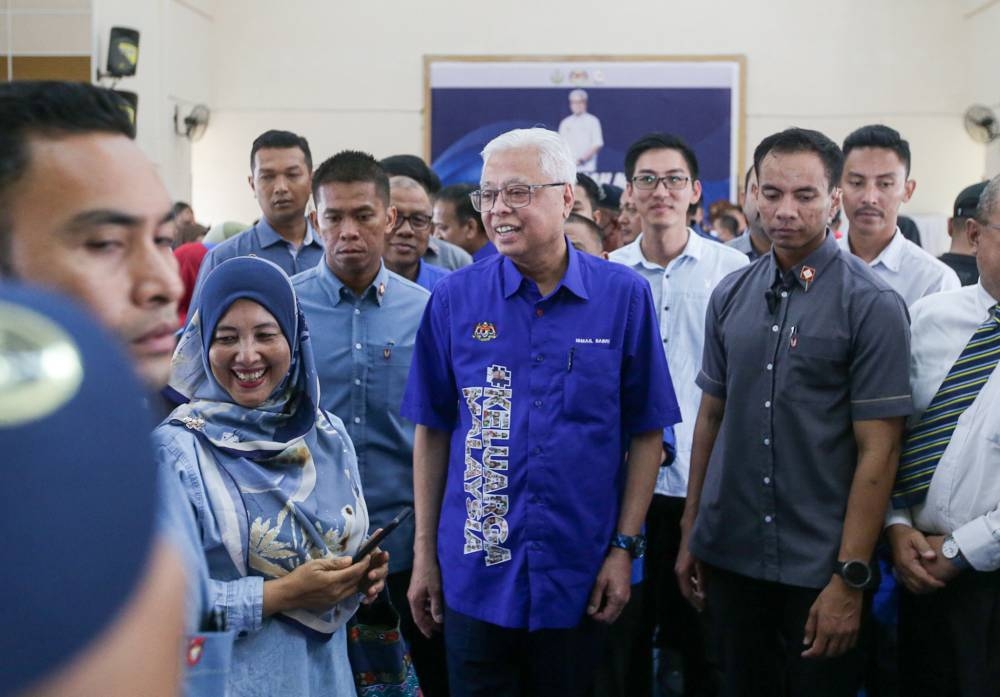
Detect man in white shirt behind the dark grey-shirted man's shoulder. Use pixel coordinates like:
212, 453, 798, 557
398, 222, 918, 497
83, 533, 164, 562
839, 125, 961, 306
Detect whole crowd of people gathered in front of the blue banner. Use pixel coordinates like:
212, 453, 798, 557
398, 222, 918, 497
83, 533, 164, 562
0, 76, 1000, 697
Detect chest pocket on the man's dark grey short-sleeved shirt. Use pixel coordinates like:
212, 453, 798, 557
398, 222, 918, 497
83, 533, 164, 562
782, 334, 850, 402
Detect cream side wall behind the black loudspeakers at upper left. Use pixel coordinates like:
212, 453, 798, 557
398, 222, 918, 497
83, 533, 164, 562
93, 0, 216, 200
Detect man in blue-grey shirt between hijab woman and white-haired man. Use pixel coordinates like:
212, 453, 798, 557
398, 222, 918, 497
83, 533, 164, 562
292, 151, 447, 697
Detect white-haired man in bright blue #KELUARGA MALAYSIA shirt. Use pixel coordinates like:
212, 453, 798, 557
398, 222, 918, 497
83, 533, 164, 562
402, 128, 679, 696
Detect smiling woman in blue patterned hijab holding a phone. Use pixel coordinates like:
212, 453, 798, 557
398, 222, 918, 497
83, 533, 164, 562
154, 257, 388, 696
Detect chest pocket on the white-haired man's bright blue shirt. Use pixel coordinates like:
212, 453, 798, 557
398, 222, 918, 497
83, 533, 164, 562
563, 346, 621, 422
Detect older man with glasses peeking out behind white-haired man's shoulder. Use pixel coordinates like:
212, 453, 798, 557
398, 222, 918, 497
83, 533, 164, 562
382, 176, 448, 290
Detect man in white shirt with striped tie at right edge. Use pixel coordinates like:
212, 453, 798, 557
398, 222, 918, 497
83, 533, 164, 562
886, 171, 1000, 697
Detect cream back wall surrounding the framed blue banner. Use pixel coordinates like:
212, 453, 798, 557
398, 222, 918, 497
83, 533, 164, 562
174, 0, 984, 220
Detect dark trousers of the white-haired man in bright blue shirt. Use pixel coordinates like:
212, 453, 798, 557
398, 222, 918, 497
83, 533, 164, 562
444, 607, 607, 697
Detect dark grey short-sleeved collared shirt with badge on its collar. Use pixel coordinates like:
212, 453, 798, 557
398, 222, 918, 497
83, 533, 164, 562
691, 233, 912, 588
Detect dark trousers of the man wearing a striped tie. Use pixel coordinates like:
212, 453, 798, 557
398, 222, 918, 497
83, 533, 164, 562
899, 570, 1000, 697
